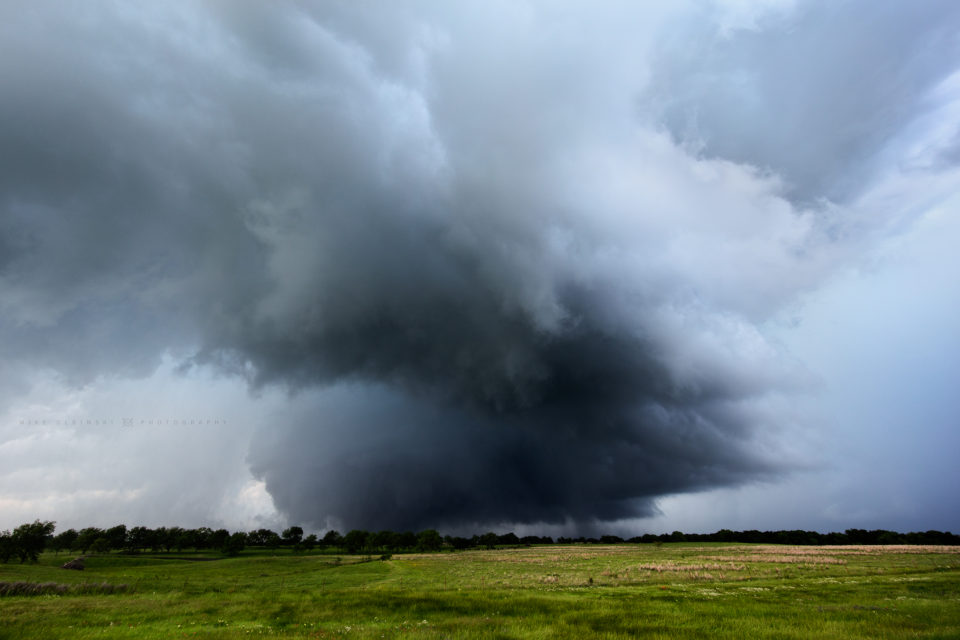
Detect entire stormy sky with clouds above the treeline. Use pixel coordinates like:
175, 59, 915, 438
0, 0, 960, 535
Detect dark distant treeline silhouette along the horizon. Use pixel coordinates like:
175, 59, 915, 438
0, 520, 960, 562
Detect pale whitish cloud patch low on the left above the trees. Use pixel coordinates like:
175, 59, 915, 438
0, 359, 278, 529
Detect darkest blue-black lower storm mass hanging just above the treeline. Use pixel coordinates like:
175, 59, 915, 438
251, 386, 776, 529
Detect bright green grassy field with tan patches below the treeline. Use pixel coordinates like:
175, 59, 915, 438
0, 544, 960, 639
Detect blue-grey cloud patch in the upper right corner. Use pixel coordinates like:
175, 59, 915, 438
644, 0, 960, 201
